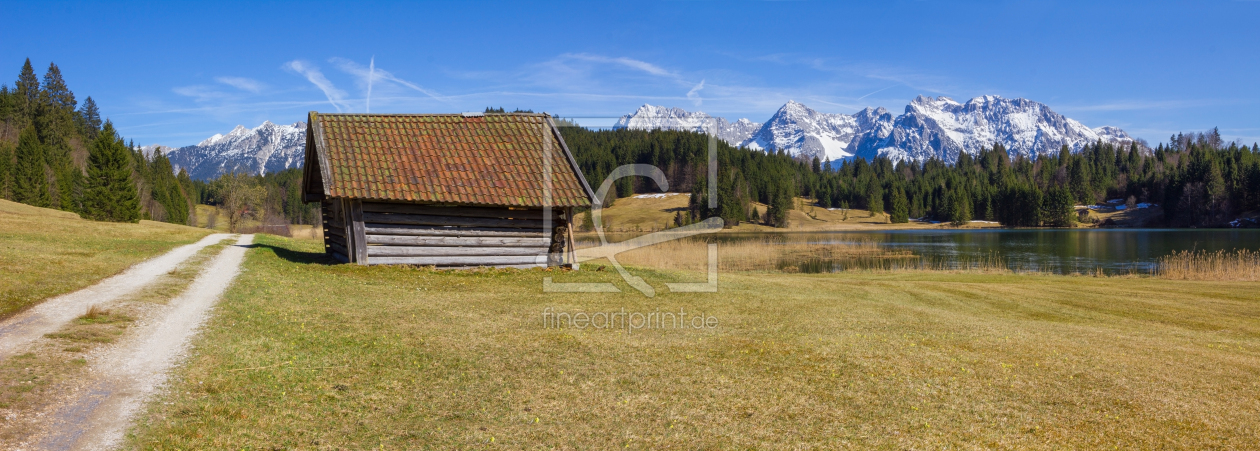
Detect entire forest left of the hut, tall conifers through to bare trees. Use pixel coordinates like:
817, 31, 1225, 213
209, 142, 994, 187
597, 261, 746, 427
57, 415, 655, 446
0, 59, 318, 230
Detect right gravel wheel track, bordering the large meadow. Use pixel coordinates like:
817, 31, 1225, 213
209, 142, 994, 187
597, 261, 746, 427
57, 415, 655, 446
35, 234, 253, 450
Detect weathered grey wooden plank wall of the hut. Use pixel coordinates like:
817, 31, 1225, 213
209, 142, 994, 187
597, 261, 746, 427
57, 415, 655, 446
321, 199, 572, 267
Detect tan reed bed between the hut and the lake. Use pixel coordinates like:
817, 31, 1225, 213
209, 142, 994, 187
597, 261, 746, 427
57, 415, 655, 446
578, 238, 1009, 273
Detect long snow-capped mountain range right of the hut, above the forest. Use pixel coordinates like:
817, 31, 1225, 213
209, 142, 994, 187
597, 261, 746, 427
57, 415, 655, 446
614, 96, 1134, 163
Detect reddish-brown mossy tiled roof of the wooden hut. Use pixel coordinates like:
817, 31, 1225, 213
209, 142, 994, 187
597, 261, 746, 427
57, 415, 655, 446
307, 112, 591, 207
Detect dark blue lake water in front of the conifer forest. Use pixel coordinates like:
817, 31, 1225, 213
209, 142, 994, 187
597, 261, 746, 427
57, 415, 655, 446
713, 229, 1260, 273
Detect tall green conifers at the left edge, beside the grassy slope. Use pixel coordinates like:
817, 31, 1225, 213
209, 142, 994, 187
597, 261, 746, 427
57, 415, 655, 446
0, 59, 190, 223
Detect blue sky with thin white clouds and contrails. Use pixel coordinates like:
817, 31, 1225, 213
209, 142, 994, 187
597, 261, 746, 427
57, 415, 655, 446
0, 0, 1260, 146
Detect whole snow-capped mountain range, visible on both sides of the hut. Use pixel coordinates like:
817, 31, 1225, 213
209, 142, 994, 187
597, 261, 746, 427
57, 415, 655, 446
152, 96, 1134, 180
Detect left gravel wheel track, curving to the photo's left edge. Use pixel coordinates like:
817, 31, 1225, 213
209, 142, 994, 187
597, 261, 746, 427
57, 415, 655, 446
0, 233, 231, 360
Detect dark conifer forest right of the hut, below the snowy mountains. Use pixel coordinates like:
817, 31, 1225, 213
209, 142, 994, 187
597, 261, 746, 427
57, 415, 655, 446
562, 127, 1260, 227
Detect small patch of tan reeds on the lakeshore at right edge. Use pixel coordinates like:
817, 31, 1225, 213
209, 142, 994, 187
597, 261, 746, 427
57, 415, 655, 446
1155, 249, 1260, 282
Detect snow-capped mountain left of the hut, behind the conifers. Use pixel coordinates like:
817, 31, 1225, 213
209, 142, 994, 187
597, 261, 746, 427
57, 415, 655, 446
166, 121, 306, 180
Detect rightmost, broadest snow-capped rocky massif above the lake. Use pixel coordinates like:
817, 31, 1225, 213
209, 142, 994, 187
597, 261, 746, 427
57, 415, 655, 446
849, 96, 1133, 161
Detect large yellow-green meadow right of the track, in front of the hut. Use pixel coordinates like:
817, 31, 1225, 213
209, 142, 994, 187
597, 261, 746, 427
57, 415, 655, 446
129, 236, 1260, 450
